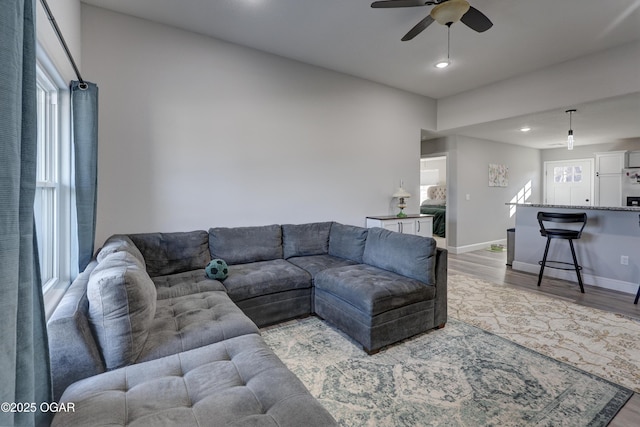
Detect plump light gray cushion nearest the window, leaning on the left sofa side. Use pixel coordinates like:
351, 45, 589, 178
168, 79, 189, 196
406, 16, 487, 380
87, 252, 156, 369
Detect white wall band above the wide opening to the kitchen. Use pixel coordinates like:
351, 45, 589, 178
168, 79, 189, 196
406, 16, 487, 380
438, 42, 640, 131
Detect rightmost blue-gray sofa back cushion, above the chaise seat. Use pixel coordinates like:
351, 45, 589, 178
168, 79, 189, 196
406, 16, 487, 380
362, 227, 436, 285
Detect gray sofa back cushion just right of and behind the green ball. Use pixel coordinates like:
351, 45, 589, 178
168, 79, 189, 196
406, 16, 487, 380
209, 225, 282, 265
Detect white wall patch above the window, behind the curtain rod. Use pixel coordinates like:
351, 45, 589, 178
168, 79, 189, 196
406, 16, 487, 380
36, 0, 80, 82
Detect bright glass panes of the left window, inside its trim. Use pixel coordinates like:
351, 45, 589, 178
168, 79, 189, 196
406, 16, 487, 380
34, 67, 60, 287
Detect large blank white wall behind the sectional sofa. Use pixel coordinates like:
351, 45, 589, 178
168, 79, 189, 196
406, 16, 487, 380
82, 5, 436, 244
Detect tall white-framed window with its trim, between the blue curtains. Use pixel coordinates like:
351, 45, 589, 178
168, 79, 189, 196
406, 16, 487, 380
34, 49, 76, 310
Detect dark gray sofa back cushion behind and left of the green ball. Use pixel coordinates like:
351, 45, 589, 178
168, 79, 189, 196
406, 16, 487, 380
129, 230, 211, 277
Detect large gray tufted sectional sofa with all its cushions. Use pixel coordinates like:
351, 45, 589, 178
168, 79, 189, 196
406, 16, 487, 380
48, 222, 447, 426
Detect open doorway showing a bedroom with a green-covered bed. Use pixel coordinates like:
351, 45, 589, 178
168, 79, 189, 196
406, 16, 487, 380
420, 154, 448, 248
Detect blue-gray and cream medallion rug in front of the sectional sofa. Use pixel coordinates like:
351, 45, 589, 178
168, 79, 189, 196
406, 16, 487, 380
262, 317, 633, 427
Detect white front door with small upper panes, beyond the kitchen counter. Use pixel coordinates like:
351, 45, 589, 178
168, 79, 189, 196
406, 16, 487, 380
544, 159, 593, 206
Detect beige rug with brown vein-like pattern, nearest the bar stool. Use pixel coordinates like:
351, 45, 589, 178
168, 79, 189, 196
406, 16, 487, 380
448, 272, 640, 392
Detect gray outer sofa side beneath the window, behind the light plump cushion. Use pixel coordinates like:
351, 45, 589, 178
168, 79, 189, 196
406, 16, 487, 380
47, 261, 105, 401
